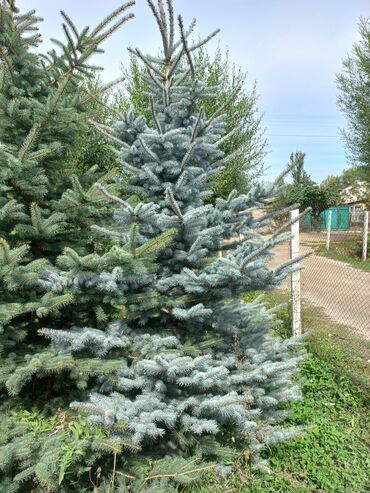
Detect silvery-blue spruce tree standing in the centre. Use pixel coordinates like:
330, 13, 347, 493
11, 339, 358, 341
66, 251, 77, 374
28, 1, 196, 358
31, 0, 308, 491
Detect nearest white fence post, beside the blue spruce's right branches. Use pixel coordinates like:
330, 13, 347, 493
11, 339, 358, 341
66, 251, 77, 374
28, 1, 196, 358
290, 209, 302, 336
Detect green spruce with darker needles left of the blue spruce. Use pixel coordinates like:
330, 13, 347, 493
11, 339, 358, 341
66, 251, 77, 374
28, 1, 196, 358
0, 0, 132, 408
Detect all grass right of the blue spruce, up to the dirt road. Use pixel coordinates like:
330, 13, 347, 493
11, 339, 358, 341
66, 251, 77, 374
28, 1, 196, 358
191, 292, 370, 493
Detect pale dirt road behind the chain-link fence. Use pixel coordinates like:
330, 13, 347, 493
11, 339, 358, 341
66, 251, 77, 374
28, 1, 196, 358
272, 243, 370, 340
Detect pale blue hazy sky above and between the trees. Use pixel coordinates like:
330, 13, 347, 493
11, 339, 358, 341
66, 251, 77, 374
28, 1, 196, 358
17, 0, 370, 182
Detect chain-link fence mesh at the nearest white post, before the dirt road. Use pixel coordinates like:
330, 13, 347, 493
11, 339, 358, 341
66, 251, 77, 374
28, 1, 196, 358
273, 208, 370, 384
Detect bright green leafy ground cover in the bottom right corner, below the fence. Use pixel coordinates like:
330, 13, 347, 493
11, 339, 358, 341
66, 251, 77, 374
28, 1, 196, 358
198, 355, 370, 493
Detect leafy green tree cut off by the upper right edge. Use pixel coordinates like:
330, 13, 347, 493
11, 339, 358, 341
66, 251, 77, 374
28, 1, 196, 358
337, 17, 370, 167
